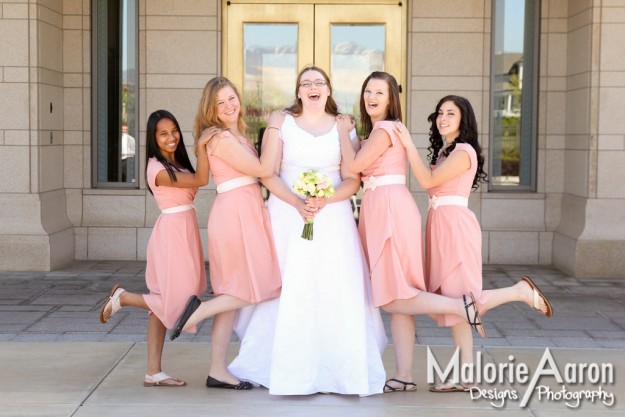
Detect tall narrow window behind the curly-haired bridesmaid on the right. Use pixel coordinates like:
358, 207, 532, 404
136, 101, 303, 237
488, 0, 540, 191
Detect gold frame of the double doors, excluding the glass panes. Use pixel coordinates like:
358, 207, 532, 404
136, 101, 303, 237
222, 0, 407, 116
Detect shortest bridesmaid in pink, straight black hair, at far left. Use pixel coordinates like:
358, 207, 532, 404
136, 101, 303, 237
100, 110, 217, 387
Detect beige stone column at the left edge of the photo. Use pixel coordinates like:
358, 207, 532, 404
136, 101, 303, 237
0, 0, 74, 271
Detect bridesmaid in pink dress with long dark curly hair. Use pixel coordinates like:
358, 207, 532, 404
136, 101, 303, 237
396, 95, 553, 392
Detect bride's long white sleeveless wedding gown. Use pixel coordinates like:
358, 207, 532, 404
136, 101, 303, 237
229, 116, 387, 395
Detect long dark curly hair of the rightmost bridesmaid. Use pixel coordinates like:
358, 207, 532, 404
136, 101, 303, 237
428, 95, 488, 190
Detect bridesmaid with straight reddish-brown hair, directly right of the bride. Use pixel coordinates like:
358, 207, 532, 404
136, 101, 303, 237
339, 71, 486, 392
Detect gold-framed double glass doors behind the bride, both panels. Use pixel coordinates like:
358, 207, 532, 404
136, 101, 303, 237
222, 0, 406, 138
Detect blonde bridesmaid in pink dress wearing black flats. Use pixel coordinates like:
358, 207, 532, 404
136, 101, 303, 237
170, 77, 281, 390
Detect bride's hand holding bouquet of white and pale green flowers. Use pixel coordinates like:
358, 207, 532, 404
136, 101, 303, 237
293, 169, 334, 240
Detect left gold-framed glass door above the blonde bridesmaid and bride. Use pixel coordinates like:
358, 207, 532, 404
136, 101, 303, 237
223, 2, 314, 141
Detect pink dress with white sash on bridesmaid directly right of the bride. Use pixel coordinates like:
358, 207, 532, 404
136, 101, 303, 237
358, 120, 426, 307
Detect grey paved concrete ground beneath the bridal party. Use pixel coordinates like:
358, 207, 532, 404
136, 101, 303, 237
0, 261, 625, 417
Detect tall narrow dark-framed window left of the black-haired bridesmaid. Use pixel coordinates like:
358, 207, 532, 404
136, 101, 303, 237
92, 0, 139, 188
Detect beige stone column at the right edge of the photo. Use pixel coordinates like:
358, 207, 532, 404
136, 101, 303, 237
547, 0, 625, 277
